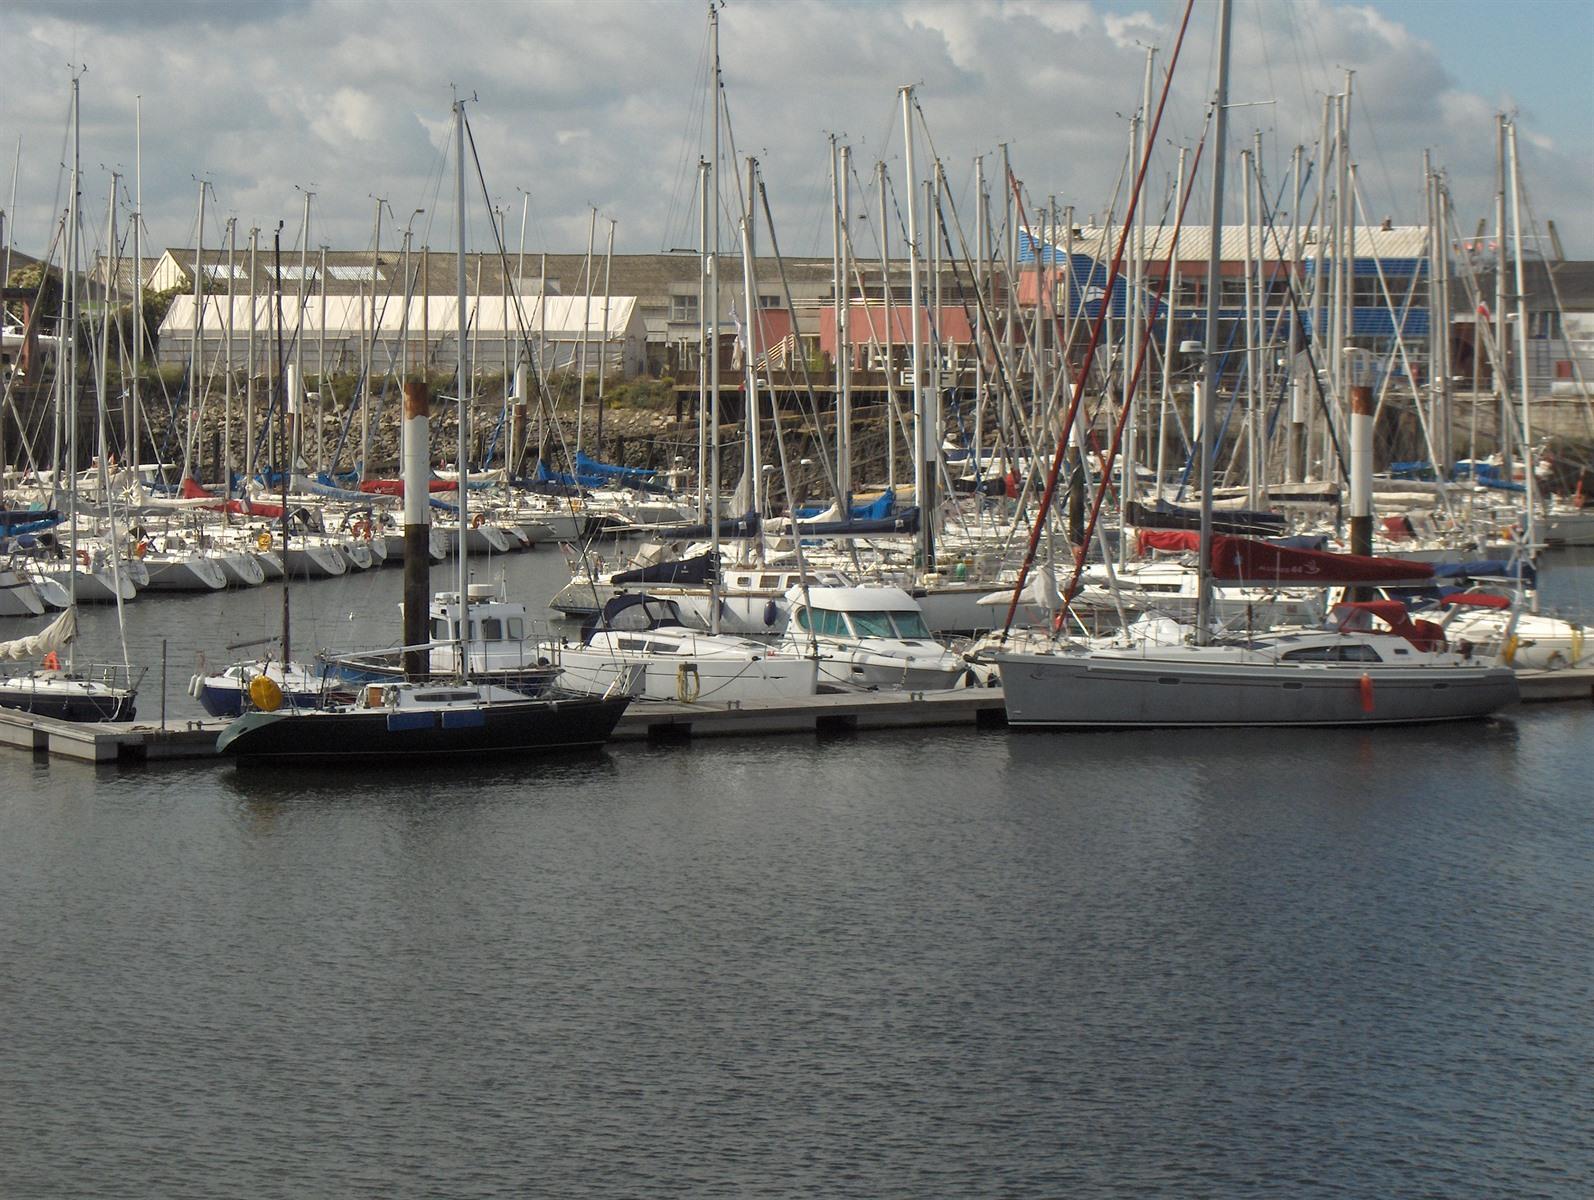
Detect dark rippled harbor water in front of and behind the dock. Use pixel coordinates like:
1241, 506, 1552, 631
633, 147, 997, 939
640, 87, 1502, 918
0, 551, 1594, 1197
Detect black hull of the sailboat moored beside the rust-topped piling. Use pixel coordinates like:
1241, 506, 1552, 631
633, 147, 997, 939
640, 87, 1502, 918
217, 696, 630, 765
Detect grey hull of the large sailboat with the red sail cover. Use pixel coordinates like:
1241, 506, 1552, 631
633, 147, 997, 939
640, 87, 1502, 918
996, 653, 1517, 728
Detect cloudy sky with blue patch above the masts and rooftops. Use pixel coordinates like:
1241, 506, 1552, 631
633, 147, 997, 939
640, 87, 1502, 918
0, 0, 1594, 266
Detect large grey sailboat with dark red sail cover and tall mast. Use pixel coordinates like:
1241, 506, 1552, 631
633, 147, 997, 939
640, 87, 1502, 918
996, 0, 1517, 728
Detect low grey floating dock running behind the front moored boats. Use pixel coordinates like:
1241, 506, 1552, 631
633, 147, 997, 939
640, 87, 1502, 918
0, 668, 1594, 763
